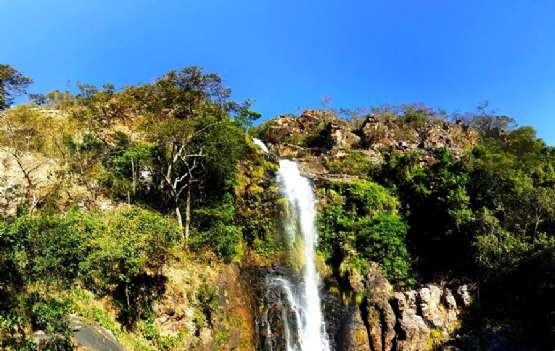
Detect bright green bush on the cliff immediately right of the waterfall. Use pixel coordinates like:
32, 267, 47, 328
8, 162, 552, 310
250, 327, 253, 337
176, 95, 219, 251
318, 181, 410, 284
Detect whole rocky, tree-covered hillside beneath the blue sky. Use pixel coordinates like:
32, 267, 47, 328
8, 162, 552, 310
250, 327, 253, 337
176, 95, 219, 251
0, 67, 555, 351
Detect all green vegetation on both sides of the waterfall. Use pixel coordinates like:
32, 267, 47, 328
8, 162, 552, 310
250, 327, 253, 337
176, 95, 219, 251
0, 65, 555, 350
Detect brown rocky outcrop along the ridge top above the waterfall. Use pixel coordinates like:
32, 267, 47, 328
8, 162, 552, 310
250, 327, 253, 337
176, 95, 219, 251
263, 110, 478, 161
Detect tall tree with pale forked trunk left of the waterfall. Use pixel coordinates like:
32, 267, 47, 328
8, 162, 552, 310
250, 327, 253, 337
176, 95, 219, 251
139, 67, 258, 239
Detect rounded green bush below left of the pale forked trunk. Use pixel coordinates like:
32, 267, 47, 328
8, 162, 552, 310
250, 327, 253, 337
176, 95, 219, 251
80, 207, 179, 326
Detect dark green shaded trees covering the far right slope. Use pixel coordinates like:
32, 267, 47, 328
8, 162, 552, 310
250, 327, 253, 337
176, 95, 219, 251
373, 114, 555, 347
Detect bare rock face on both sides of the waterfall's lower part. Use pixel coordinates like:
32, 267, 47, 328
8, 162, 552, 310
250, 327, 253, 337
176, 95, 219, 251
252, 263, 472, 351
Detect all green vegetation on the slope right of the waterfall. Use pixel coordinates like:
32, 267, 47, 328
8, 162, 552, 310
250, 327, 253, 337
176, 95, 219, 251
312, 106, 555, 348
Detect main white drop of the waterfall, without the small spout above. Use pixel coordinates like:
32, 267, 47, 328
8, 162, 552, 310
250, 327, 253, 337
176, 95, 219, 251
272, 160, 330, 351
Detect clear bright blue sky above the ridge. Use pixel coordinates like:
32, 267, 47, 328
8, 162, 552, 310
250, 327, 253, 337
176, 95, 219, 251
0, 0, 555, 145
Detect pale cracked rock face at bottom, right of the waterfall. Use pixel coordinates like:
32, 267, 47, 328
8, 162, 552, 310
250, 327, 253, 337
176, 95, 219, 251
340, 264, 472, 351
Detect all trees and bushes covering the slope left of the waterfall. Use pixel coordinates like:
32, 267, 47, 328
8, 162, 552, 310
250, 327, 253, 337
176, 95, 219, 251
0, 66, 274, 350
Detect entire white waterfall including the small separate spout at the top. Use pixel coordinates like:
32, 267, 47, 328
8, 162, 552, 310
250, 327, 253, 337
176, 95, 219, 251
253, 138, 330, 351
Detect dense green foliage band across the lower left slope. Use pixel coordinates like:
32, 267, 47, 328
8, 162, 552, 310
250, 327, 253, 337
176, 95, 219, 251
0, 208, 178, 348
